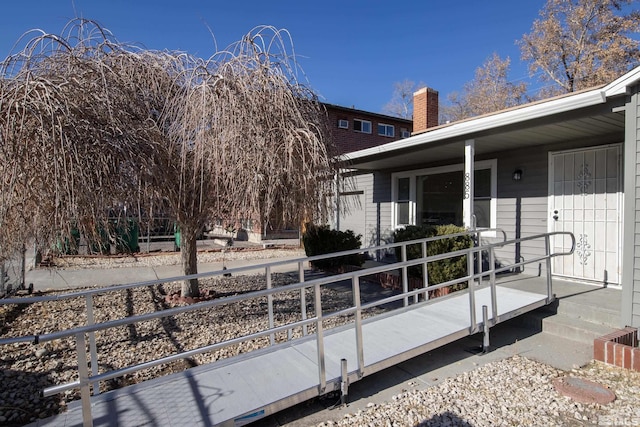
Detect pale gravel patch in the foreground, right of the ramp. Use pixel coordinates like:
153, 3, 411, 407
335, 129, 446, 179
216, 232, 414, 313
320, 355, 640, 427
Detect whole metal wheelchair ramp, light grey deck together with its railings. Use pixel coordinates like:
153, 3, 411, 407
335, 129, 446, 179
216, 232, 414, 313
10, 232, 575, 426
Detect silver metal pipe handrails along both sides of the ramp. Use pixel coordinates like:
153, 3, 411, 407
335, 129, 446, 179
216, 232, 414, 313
0, 232, 576, 425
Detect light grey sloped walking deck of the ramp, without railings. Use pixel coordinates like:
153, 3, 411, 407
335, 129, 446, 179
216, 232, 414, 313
32, 286, 547, 426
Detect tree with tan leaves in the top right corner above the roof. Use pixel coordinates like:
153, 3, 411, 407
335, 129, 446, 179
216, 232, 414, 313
519, 0, 640, 97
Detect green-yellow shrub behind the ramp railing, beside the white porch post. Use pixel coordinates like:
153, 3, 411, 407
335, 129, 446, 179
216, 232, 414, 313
393, 225, 473, 290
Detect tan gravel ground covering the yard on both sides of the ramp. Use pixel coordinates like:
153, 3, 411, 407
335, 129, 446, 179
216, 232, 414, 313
0, 249, 640, 426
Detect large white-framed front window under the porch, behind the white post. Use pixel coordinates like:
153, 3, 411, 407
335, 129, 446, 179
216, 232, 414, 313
393, 160, 497, 228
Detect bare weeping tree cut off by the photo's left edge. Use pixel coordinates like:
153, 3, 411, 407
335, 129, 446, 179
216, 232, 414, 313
0, 20, 165, 264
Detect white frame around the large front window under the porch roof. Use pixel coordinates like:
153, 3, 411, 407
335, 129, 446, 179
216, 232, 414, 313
391, 159, 498, 232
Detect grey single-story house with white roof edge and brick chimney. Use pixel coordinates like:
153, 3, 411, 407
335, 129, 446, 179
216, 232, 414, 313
345, 68, 640, 327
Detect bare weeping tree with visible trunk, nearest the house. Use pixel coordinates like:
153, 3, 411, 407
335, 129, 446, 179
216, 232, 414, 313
161, 27, 338, 296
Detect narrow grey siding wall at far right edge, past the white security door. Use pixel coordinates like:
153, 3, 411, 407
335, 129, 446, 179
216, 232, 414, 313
620, 86, 640, 327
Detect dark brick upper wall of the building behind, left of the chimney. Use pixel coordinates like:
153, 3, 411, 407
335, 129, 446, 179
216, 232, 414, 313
325, 104, 413, 154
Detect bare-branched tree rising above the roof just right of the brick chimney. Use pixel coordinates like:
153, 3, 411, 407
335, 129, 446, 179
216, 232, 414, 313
442, 53, 527, 121
